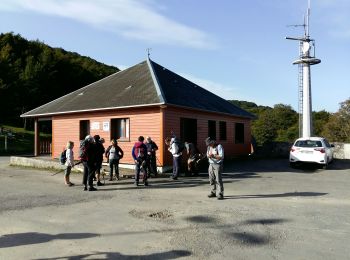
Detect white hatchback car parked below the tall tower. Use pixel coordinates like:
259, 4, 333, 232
289, 137, 334, 168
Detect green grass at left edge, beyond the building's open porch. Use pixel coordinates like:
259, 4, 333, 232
0, 125, 51, 155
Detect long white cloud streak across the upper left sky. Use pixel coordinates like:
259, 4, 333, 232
0, 0, 217, 49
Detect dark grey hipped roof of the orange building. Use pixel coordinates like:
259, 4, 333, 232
21, 59, 253, 118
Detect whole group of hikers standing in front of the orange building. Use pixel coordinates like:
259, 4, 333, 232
61, 133, 224, 199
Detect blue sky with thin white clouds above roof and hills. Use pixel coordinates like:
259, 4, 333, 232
0, 0, 350, 112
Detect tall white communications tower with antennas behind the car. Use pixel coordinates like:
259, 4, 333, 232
286, 0, 321, 137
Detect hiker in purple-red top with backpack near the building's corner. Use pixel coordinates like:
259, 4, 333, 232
131, 136, 148, 186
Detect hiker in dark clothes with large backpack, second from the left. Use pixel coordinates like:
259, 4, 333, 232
79, 135, 97, 191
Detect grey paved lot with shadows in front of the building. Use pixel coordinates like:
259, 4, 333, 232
0, 157, 350, 259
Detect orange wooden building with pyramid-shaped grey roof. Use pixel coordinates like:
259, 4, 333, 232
21, 59, 253, 170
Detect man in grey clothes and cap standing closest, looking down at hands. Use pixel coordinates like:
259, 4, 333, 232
205, 137, 224, 200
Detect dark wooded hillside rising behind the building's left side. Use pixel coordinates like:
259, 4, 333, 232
0, 33, 119, 125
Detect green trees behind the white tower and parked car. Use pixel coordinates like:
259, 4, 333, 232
230, 99, 350, 145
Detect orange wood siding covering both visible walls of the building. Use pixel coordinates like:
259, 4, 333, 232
52, 106, 251, 166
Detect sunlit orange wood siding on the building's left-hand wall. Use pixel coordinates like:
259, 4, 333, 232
52, 107, 161, 164
